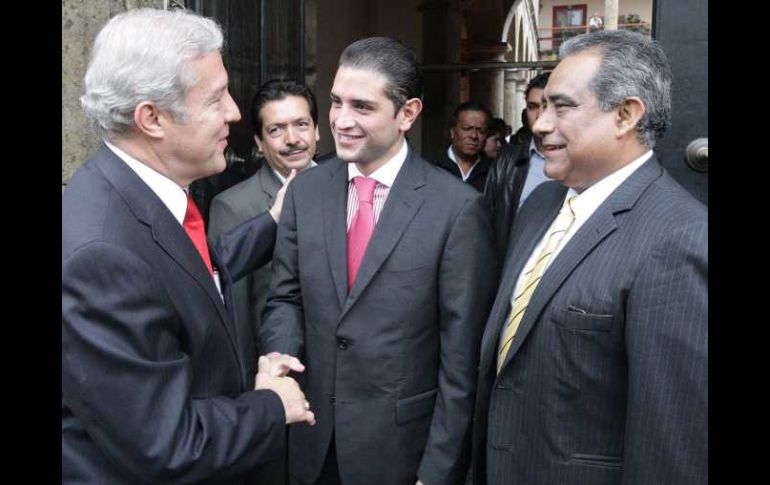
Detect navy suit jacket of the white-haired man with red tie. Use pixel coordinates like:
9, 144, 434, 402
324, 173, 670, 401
62, 146, 286, 484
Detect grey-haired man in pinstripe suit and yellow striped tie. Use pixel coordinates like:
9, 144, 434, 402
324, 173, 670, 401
474, 31, 708, 485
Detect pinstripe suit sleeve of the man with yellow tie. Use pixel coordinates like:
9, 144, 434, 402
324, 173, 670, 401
623, 216, 708, 483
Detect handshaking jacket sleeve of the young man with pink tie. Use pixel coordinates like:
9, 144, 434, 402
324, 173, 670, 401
259, 183, 305, 356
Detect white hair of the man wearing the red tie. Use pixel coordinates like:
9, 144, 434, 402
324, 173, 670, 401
80, 9, 223, 138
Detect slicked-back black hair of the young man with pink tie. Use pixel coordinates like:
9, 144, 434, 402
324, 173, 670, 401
339, 37, 422, 113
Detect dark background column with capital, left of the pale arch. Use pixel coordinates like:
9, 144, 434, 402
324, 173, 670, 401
467, 42, 510, 116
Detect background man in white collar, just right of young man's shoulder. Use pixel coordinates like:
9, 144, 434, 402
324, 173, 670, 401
437, 101, 492, 192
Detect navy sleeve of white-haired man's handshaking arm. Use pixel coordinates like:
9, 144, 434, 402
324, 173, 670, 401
62, 243, 286, 483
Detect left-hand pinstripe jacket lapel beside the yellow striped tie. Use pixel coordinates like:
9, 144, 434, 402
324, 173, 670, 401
474, 182, 567, 366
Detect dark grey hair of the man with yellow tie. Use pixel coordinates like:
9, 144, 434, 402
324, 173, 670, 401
559, 30, 671, 148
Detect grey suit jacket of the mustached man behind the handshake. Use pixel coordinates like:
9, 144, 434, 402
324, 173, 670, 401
208, 163, 281, 381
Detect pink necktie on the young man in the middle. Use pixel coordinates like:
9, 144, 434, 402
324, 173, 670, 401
348, 177, 377, 291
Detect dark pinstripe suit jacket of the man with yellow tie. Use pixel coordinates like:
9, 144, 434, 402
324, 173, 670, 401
474, 156, 708, 485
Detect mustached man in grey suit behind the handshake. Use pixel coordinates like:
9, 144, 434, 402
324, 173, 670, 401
208, 79, 319, 386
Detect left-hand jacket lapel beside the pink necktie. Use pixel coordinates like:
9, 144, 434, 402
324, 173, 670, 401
323, 161, 348, 307
